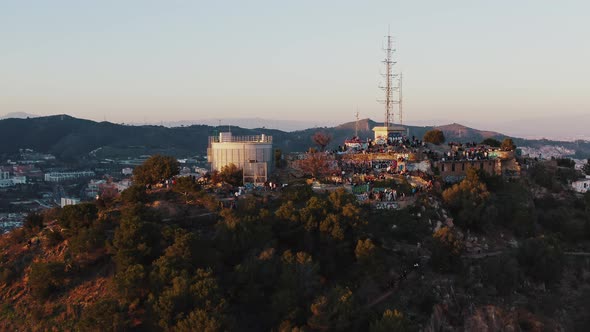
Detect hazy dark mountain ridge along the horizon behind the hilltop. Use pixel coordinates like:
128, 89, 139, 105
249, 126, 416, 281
0, 115, 590, 159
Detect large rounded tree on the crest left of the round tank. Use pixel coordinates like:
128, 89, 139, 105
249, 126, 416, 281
133, 155, 179, 185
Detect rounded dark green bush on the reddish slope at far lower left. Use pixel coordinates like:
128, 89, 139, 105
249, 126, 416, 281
29, 262, 65, 299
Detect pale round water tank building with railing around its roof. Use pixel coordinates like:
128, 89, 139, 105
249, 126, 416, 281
207, 132, 274, 184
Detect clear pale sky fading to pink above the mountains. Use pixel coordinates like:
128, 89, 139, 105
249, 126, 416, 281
0, 0, 590, 137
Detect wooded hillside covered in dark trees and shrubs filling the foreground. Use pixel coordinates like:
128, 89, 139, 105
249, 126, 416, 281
0, 161, 590, 332
